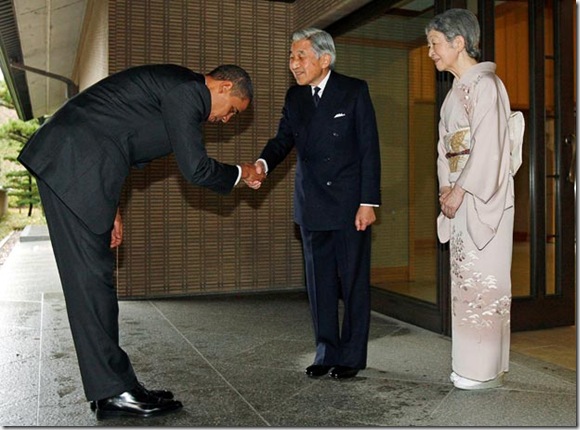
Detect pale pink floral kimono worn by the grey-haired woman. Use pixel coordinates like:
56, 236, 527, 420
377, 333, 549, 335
437, 62, 514, 381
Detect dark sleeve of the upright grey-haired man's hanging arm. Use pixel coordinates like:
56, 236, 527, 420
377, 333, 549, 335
356, 82, 381, 205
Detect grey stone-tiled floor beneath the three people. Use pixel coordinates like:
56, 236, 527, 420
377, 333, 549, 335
0, 228, 578, 427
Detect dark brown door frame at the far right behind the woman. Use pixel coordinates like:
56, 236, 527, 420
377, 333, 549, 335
511, 0, 576, 331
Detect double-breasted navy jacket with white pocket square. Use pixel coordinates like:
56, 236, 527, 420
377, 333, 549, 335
260, 71, 381, 230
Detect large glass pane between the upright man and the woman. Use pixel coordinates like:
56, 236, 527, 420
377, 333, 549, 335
335, 2, 438, 303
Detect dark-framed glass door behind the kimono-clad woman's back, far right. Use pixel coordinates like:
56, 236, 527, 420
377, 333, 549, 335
494, 0, 576, 331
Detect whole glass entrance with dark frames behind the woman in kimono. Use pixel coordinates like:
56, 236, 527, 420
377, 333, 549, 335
327, 0, 576, 334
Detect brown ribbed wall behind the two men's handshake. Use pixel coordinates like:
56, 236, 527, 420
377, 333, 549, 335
109, 0, 304, 298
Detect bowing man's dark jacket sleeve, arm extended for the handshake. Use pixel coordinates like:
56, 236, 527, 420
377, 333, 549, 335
161, 82, 239, 194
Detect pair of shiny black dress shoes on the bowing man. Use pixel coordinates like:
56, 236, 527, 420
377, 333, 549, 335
95, 385, 183, 420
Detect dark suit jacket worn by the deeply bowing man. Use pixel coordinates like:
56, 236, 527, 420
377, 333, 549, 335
18, 65, 238, 234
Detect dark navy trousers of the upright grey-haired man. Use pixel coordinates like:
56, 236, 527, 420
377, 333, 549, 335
301, 223, 371, 369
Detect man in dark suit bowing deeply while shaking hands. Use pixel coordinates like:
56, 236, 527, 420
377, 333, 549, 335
18, 65, 262, 419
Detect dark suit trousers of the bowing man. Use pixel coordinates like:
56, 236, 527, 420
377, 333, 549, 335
37, 179, 137, 400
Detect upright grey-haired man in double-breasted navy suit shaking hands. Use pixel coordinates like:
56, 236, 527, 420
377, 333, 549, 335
248, 28, 381, 379
